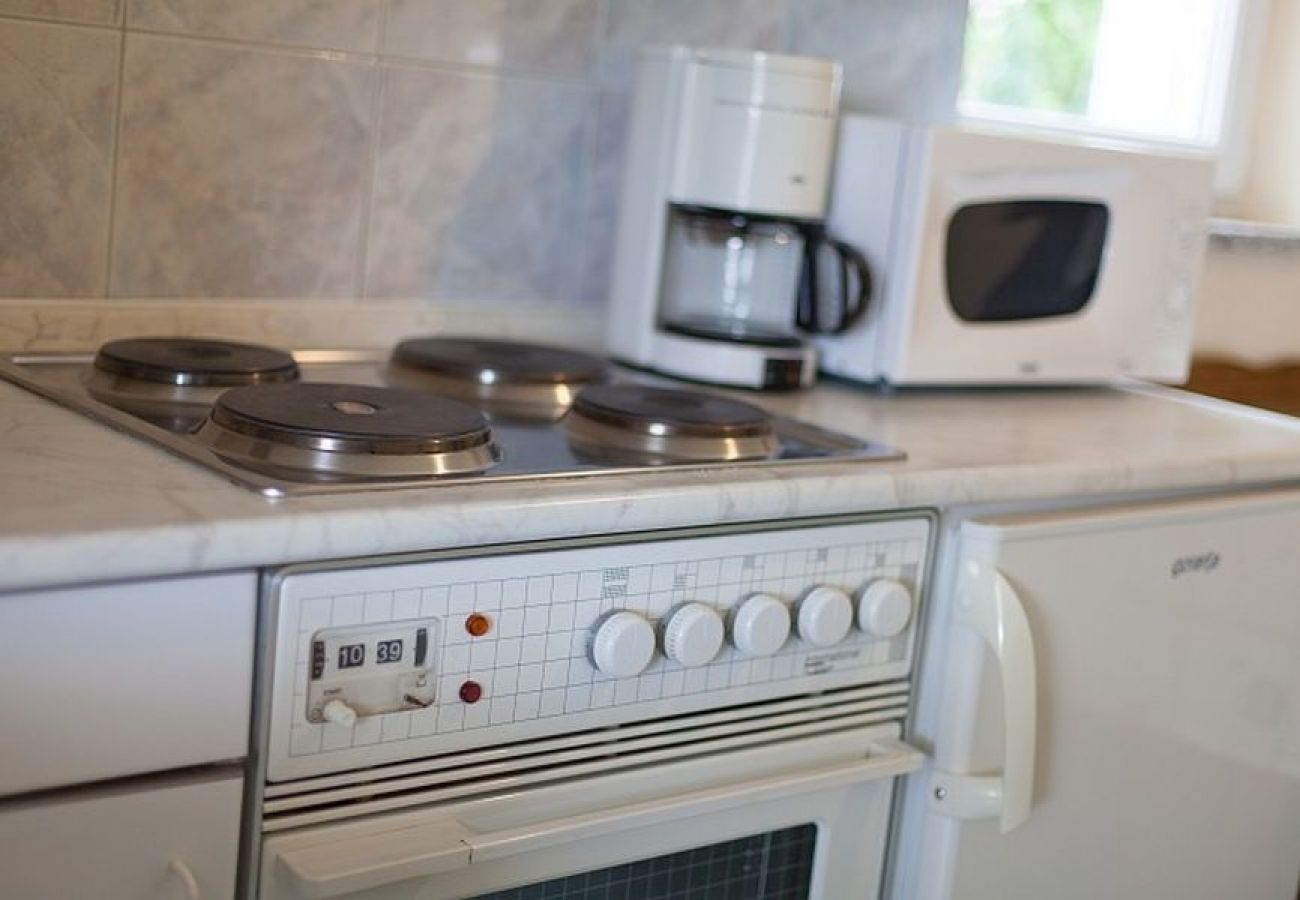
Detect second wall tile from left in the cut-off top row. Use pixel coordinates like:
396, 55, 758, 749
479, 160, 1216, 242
126, 0, 384, 52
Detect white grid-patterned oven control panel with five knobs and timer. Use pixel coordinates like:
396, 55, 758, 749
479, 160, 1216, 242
268, 516, 932, 780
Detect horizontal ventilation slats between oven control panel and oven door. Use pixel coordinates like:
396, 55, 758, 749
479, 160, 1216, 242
263, 680, 910, 831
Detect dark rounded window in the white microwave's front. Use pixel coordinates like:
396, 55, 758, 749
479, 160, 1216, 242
945, 200, 1110, 323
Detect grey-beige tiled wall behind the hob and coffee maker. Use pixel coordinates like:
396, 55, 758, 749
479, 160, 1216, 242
0, 0, 966, 331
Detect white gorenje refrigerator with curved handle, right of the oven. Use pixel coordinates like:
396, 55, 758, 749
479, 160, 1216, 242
889, 492, 1300, 900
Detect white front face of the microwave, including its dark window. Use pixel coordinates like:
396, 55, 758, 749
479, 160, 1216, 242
881, 133, 1209, 384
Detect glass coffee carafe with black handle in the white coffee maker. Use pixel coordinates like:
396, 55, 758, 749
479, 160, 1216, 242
659, 207, 871, 347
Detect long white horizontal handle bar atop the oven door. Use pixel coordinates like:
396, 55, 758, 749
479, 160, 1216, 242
278, 739, 924, 897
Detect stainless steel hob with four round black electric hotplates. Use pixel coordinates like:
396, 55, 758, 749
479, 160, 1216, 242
0, 339, 904, 498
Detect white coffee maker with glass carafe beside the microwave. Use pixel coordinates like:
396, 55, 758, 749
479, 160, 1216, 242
608, 47, 870, 388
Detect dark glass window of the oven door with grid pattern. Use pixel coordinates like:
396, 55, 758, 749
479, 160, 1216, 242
473, 825, 816, 900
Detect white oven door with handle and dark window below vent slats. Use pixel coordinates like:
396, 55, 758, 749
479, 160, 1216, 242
260, 723, 922, 900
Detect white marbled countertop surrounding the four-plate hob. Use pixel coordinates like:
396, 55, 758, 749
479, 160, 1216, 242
0, 384, 1300, 589
